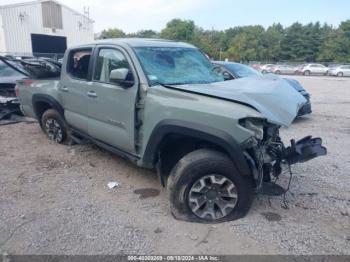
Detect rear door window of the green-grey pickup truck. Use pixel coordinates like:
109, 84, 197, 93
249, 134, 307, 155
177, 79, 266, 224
68, 49, 92, 80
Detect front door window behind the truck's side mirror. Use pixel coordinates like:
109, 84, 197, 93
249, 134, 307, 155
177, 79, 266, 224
94, 48, 133, 84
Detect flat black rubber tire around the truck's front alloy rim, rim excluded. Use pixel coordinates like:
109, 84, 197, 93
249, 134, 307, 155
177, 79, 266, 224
167, 149, 254, 223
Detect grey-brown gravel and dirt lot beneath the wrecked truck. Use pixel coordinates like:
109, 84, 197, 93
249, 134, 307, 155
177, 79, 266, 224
0, 77, 350, 254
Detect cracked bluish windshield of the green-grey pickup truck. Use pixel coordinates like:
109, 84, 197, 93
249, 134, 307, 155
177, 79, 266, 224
135, 47, 224, 85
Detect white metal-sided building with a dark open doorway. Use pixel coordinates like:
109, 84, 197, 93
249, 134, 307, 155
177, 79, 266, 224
0, 0, 94, 55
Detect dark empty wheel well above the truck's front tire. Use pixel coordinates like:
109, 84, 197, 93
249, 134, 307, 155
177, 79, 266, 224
156, 134, 229, 186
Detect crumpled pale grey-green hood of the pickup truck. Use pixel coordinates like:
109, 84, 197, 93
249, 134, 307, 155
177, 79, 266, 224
176, 77, 306, 126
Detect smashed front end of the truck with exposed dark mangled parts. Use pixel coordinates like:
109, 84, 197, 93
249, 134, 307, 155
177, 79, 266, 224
240, 118, 327, 195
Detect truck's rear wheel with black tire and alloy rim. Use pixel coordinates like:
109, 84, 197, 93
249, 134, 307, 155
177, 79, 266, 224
41, 108, 71, 144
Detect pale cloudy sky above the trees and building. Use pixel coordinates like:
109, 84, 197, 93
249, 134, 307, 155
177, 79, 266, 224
0, 0, 350, 33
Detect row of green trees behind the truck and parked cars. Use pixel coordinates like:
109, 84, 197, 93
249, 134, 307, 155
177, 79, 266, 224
101, 19, 350, 63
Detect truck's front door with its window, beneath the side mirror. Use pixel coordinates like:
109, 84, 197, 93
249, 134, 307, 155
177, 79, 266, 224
88, 46, 138, 153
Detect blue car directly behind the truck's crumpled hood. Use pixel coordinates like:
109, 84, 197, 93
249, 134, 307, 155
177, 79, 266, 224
213, 61, 312, 116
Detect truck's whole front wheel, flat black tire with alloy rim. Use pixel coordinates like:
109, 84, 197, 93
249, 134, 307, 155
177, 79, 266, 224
167, 149, 254, 223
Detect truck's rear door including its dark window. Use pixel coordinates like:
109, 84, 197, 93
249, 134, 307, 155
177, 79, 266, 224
58, 47, 93, 134
